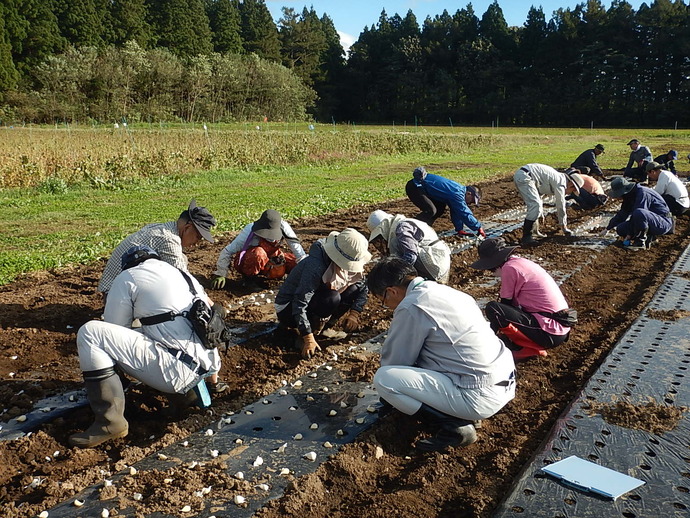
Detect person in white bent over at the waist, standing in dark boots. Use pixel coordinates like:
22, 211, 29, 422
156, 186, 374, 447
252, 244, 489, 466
513, 164, 584, 245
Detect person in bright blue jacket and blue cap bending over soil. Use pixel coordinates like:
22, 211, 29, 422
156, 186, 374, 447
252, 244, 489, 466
405, 167, 486, 237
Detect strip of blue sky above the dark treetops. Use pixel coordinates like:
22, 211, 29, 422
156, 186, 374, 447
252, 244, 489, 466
266, 0, 651, 50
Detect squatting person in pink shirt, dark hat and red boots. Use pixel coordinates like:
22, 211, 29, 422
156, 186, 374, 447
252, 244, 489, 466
470, 238, 570, 360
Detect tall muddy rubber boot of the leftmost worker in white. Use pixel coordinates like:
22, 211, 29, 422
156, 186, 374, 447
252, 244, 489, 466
69, 368, 129, 448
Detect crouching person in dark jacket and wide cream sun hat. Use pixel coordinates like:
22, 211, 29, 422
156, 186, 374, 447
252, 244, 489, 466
275, 228, 371, 358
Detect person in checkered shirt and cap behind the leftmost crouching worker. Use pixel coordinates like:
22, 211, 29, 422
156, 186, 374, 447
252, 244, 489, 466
98, 200, 216, 294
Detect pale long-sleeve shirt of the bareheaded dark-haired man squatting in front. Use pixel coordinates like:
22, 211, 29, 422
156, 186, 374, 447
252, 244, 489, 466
381, 277, 515, 388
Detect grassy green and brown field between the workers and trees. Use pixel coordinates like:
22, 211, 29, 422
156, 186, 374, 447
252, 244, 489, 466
0, 123, 690, 284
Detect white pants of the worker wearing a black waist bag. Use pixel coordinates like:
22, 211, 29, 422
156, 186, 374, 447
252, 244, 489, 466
77, 320, 203, 394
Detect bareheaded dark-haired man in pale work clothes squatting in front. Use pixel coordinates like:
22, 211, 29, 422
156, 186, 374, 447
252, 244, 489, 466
367, 257, 515, 451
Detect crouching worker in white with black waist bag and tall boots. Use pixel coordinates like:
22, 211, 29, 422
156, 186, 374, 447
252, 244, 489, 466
69, 246, 220, 448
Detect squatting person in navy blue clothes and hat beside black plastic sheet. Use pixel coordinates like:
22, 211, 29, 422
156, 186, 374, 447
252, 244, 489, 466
602, 177, 673, 249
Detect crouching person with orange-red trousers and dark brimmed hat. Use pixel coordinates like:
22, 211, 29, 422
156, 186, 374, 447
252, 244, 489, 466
213, 209, 306, 289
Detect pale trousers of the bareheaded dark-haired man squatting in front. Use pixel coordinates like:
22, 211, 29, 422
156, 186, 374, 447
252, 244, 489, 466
374, 365, 515, 421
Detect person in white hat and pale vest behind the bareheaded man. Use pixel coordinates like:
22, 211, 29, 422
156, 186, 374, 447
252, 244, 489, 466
367, 210, 450, 284
